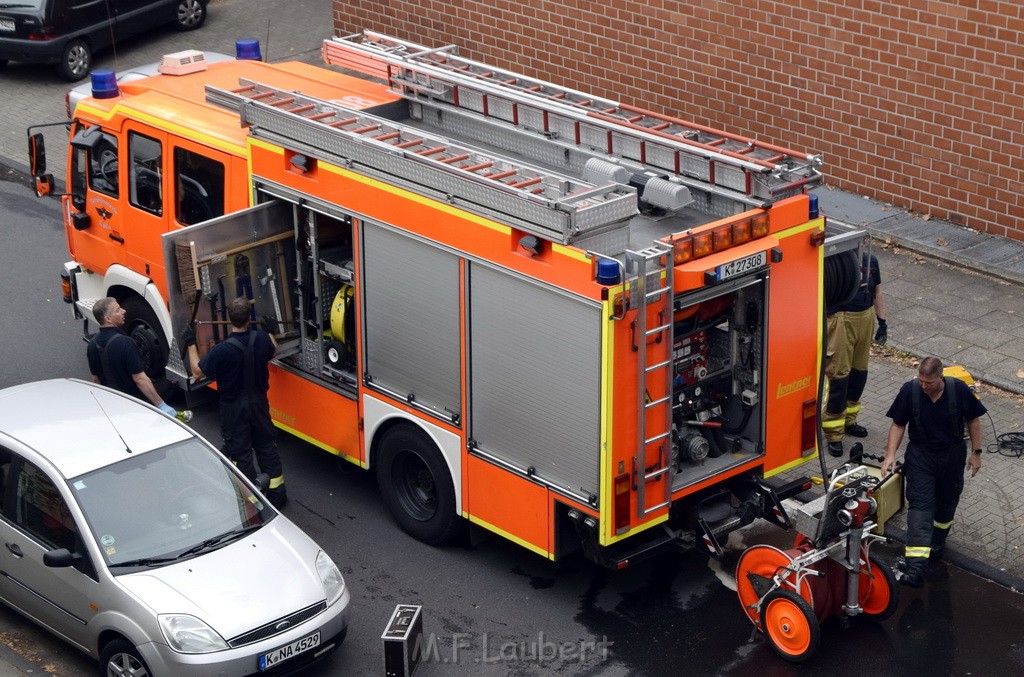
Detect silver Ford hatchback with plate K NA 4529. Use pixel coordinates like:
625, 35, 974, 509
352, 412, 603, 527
0, 379, 351, 677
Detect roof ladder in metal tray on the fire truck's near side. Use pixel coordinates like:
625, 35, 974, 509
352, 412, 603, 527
206, 80, 636, 244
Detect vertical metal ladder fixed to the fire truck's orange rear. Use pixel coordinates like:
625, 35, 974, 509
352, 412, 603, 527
626, 243, 673, 517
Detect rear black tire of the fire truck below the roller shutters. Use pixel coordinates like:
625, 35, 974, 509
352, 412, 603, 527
377, 425, 462, 545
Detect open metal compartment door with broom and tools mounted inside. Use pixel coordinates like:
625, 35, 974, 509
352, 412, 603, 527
161, 200, 299, 380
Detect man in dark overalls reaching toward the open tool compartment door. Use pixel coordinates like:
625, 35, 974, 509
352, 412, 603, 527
181, 296, 288, 508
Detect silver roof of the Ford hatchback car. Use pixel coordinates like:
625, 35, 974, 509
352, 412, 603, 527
0, 379, 196, 478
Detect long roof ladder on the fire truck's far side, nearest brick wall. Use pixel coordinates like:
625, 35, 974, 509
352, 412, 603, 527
323, 31, 822, 205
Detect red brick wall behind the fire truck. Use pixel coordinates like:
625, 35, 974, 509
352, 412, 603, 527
334, 0, 1024, 241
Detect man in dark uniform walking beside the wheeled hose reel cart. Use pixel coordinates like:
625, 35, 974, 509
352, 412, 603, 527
882, 357, 987, 588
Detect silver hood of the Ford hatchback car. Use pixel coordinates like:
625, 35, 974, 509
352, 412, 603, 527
118, 516, 325, 640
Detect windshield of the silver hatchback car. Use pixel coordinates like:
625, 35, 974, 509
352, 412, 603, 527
69, 439, 275, 573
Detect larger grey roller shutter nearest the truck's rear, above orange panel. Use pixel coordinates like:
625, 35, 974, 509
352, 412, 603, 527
470, 264, 601, 496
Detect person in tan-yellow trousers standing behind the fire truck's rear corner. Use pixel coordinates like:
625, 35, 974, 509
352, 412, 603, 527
821, 253, 889, 457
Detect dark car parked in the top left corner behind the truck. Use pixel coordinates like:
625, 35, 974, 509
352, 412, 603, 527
0, 0, 208, 82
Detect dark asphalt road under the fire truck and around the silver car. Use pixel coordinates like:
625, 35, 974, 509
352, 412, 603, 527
0, 173, 1024, 677
